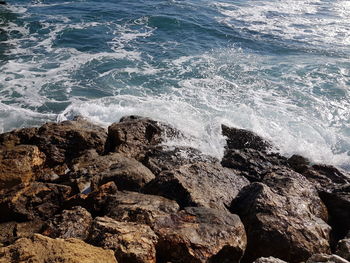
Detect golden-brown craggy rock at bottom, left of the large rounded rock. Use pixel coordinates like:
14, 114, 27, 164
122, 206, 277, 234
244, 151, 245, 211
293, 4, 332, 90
91, 217, 158, 263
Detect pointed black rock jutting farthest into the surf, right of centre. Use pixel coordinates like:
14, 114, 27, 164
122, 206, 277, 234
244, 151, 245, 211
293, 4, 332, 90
221, 125, 272, 151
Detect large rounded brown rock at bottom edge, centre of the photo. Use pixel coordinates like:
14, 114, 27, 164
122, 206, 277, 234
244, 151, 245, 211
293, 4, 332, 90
154, 207, 247, 263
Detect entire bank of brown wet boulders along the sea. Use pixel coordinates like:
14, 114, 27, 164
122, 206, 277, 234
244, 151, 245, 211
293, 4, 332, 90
0, 116, 350, 263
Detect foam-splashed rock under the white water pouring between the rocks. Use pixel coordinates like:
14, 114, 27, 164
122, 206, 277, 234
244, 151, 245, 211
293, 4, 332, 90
142, 146, 219, 175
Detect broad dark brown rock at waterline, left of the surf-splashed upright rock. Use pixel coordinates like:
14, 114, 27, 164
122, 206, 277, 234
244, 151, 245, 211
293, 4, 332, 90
31, 118, 107, 166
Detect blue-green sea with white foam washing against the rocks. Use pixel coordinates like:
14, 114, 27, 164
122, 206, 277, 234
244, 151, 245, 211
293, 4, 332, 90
0, 0, 350, 168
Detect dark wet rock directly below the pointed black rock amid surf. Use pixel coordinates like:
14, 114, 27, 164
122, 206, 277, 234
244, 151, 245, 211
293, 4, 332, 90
221, 148, 288, 182
